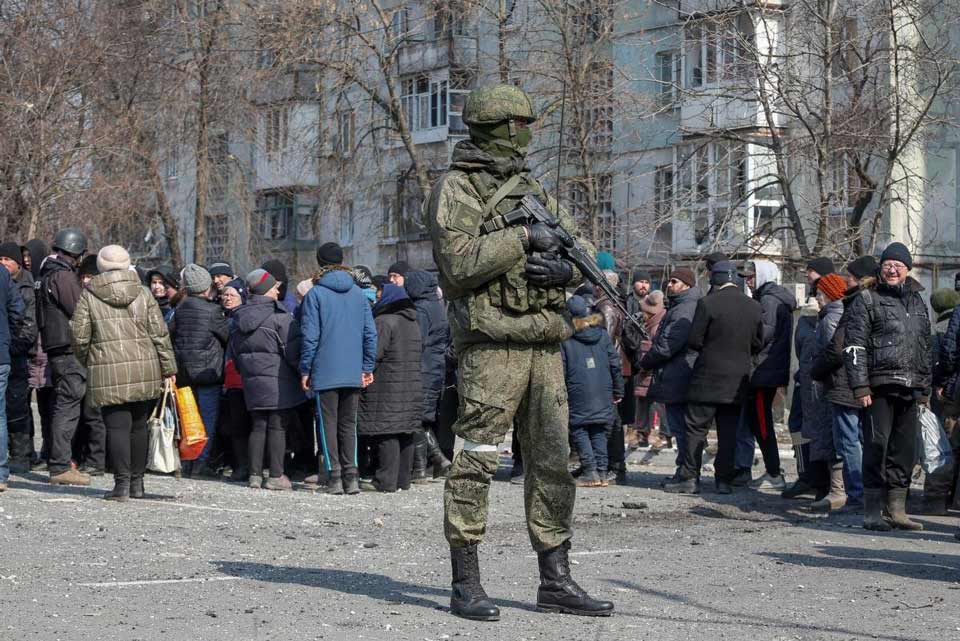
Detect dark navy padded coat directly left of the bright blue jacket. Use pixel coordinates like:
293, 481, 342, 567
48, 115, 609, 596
230, 296, 305, 411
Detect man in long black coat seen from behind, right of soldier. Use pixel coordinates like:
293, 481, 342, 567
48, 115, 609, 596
664, 261, 763, 494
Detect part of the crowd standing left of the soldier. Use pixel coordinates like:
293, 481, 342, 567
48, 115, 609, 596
0, 229, 455, 501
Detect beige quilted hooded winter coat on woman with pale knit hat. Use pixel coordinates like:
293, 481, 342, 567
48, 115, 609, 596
70, 271, 177, 407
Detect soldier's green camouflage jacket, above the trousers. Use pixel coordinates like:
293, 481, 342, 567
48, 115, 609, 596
424, 141, 592, 351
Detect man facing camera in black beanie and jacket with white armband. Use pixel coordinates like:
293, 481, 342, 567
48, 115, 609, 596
843, 243, 931, 531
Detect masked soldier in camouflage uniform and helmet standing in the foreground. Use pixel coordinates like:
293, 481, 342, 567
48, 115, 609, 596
425, 85, 613, 620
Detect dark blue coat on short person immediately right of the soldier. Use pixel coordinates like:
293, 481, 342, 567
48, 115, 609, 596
560, 314, 623, 427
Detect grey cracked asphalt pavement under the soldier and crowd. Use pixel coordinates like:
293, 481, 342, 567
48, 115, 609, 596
0, 444, 960, 641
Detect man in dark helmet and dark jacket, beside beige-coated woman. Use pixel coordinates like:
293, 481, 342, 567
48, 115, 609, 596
37, 229, 106, 485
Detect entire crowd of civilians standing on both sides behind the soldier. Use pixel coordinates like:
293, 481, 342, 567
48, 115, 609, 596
0, 229, 960, 530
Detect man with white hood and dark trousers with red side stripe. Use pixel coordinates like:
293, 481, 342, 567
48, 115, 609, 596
738, 260, 797, 491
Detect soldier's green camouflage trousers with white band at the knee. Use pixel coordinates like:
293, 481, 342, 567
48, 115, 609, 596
443, 343, 576, 552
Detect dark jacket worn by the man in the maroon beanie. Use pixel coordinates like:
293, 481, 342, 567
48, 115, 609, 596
639, 287, 701, 403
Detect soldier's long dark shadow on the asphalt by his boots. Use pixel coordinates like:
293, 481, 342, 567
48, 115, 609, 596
211, 561, 536, 612
